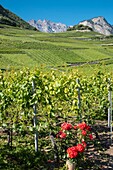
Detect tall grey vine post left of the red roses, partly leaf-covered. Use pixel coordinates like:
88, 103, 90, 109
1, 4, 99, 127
32, 81, 38, 152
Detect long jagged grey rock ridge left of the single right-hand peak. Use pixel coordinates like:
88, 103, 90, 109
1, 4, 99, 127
28, 20, 67, 33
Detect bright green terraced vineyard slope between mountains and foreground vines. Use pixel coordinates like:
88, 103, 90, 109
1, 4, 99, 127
0, 25, 113, 70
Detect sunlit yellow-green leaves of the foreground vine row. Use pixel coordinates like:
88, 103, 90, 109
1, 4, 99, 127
0, 69, 113, 136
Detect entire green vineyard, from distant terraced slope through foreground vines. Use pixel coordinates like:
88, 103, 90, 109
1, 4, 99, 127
0, 25, 113, 170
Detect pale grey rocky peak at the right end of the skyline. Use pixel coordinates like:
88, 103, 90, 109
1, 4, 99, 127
78, 16, 113, 35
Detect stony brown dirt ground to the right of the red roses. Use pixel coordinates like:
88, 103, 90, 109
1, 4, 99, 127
90, 121, 113, 170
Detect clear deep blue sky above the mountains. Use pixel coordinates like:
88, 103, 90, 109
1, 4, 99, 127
0, 0, 113, 26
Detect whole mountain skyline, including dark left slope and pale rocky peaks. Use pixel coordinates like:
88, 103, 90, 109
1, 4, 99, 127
0, 5, 113, 35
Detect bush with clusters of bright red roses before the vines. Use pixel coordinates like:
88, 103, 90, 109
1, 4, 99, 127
56, 122, 93, 163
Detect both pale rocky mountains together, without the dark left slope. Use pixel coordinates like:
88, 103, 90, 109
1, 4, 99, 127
28, 16, 113, 35
